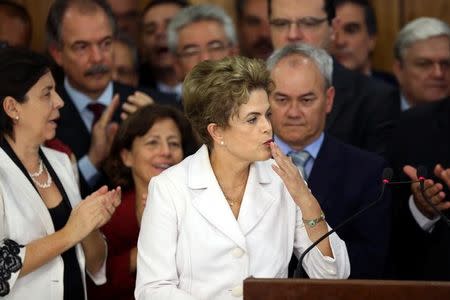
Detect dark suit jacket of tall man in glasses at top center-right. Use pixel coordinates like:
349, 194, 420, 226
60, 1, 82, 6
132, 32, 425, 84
326, 62, 400, 155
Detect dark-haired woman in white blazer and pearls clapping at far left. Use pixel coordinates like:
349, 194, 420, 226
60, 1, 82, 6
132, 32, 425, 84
0, 48, 120, 300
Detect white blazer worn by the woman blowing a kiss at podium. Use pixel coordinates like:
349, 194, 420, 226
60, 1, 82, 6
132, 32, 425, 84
135, 146, 350, 300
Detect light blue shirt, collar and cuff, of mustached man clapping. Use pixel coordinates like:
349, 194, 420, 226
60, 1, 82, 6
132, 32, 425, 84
64, 77, 113, 187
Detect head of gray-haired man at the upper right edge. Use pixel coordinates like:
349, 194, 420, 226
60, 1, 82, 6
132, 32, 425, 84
393, 17, 450, 110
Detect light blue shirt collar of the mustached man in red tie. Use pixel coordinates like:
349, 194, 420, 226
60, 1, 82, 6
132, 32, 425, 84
64, 76, 113, 132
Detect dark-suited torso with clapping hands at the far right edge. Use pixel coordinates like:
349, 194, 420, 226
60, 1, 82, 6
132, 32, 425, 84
390, 98, 450, 280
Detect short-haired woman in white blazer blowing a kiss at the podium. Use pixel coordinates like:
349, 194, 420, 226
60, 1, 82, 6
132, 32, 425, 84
135, 57, 350, 300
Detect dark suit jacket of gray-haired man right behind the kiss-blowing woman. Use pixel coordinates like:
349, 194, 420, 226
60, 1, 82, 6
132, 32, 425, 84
290, 135, 390, 278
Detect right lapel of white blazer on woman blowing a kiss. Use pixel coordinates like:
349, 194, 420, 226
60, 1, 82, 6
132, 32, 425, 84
238, 162, 276, 235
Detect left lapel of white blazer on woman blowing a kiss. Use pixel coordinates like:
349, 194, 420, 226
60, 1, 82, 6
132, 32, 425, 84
188, 145, 247, 250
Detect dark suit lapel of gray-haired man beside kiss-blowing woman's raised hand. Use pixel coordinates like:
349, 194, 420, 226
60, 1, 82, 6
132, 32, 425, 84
308, 135, 339, 211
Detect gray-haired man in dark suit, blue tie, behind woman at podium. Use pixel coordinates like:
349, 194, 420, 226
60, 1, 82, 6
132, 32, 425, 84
267, 44, 390, 278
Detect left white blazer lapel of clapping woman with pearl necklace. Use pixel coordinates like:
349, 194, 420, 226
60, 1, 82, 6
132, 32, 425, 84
0, 149, 55, 234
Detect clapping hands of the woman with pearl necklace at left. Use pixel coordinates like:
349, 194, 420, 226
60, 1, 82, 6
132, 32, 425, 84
64, 186, 121, 243
